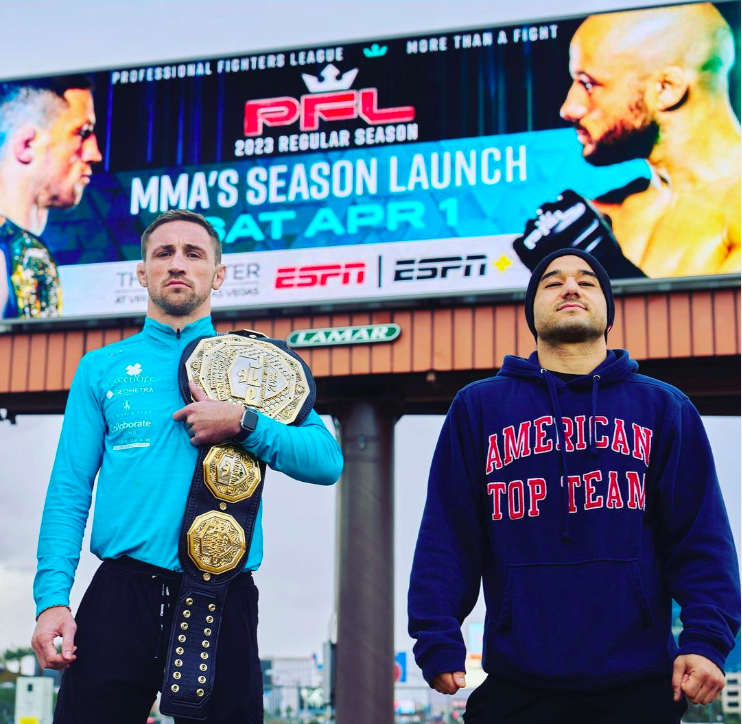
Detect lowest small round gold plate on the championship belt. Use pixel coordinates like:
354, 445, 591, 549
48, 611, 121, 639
187, 510, 246, 573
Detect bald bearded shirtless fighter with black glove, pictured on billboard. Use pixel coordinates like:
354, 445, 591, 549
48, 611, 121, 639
514, 3, 740, 278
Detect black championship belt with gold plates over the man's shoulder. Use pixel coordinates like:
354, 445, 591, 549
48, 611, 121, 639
160, 331, 316, 719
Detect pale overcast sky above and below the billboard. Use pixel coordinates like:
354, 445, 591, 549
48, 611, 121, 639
0, 0, 740, 684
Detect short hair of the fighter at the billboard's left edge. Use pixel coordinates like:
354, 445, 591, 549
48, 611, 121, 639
0, 74, 94, 152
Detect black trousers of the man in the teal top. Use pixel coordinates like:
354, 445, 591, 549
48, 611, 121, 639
54, 557, 263, 724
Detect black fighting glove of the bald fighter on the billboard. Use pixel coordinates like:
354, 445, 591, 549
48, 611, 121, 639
513, 190, 646, 279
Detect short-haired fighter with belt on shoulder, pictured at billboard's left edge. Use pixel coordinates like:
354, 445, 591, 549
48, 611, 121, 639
0, 75, 102, 319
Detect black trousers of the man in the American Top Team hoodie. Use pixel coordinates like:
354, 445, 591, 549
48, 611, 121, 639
464, 676, 688, 724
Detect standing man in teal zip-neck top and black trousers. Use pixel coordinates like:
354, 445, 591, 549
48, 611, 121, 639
32, 206, 343, 724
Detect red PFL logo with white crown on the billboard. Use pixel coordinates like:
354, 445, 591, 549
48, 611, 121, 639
244, 64, 415, 137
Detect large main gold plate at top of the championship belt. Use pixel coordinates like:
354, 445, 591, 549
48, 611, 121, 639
186, 334, 309, 424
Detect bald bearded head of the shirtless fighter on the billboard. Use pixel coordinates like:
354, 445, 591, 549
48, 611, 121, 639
560, 4, 734, 166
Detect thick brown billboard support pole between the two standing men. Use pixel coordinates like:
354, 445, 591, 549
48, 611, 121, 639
335, 399, 397, 724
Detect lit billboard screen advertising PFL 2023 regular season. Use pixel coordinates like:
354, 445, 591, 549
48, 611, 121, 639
0, 2, 740, 319
